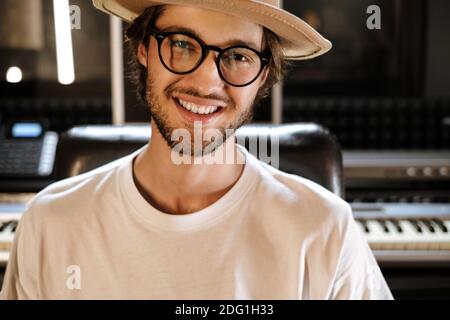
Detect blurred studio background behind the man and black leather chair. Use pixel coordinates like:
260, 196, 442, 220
0, 0, 450, 299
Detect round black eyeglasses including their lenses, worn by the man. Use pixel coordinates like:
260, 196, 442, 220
146, 29, 270, 87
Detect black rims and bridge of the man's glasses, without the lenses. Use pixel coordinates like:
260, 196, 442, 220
145, 28, 271, 88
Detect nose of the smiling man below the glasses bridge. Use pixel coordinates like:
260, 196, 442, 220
187, 51, 225, 95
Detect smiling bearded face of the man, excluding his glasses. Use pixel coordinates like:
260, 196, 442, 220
138, 6, 267, 154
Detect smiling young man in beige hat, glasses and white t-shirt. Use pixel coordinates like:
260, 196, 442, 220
2, 0, 392, 299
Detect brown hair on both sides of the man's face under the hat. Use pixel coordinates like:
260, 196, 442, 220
126, 5, 287, 103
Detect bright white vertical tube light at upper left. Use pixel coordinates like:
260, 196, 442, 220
53, 0, 75, 85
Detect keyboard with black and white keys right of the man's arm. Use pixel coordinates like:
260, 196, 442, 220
351, 203, 450, 262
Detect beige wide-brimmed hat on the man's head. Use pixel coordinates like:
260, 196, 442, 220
93, 0, 332, 60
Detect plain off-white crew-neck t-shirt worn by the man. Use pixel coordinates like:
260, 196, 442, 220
0, 148, 392, 300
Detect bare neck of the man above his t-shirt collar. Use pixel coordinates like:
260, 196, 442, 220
133, 122, 244, 215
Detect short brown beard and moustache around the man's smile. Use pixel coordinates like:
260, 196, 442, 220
146, 74, 254, 157
